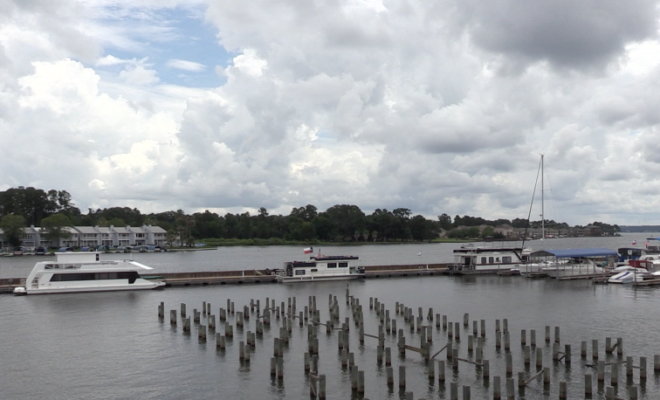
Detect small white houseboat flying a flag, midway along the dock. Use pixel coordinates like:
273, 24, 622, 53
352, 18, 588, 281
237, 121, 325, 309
276, 255, 365, 282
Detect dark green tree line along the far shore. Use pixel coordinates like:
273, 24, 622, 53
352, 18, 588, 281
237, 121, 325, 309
0, 186, 618, 245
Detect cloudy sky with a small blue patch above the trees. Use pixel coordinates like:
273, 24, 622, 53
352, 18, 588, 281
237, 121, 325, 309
0, 0, 660, 225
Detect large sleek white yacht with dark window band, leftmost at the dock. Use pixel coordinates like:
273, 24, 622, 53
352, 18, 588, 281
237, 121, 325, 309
14, 252, 165, 294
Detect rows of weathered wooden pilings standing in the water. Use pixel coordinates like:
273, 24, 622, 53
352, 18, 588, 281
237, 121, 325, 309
158, 288, 660, 400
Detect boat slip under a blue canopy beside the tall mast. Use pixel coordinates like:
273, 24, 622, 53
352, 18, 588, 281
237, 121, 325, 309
521, 247, 618, 279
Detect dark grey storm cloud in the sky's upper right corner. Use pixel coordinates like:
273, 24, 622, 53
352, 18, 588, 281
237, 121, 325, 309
459, 0, 658, 69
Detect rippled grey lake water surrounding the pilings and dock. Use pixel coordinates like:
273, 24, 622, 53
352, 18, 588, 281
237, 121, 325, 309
0, 234, 660, 400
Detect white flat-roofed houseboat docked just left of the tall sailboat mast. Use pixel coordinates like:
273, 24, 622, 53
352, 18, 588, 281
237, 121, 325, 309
449, 244, 532, 272
